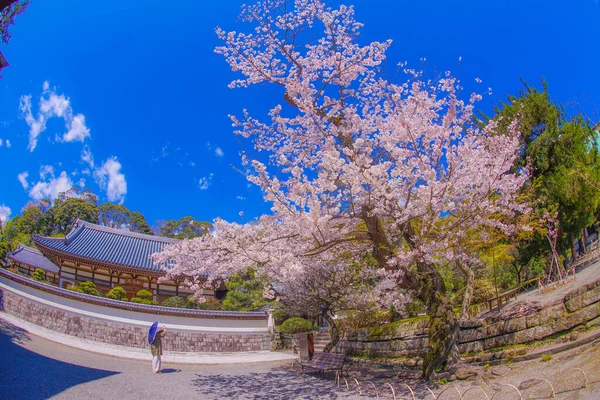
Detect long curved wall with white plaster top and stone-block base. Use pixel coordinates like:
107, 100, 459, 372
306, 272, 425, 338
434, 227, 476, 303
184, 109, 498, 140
0, 271, 271, 352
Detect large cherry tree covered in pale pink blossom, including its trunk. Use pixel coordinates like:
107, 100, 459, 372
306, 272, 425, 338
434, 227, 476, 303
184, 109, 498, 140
156, 0, 527, 377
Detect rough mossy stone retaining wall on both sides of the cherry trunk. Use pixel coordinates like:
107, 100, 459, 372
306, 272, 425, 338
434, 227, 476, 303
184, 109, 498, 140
337, 279, 600, 359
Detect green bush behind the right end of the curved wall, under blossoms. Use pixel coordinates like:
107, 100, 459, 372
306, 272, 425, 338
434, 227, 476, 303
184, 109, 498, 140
223, 268, 268, 311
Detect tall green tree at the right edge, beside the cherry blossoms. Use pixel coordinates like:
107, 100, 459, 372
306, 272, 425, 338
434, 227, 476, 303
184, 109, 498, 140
494, 81, 600, 256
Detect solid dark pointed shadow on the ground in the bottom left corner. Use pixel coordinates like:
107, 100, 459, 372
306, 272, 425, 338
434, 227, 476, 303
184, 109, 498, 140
0, 320, 118, 400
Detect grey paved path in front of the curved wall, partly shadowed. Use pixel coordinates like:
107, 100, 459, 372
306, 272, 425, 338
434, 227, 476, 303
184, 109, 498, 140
0, 321, 364, 400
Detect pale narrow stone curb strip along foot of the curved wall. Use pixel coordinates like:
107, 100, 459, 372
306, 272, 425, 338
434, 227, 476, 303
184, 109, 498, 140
0, 312, 298, 364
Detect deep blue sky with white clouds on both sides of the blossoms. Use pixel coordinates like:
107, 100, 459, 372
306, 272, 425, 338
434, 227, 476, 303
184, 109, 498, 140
0, 0, 600, 225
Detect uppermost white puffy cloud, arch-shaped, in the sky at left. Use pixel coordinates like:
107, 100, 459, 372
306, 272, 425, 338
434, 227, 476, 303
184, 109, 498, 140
19, 81, 90, 151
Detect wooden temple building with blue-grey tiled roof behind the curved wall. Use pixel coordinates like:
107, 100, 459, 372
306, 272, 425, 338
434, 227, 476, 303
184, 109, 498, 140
8, 220, 225, 302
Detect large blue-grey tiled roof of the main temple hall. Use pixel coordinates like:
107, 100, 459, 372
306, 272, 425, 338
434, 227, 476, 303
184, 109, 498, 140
33, 220, 178, 272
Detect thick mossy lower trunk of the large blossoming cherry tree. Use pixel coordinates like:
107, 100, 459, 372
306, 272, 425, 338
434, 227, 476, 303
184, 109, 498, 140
417, 264, 460, 380
